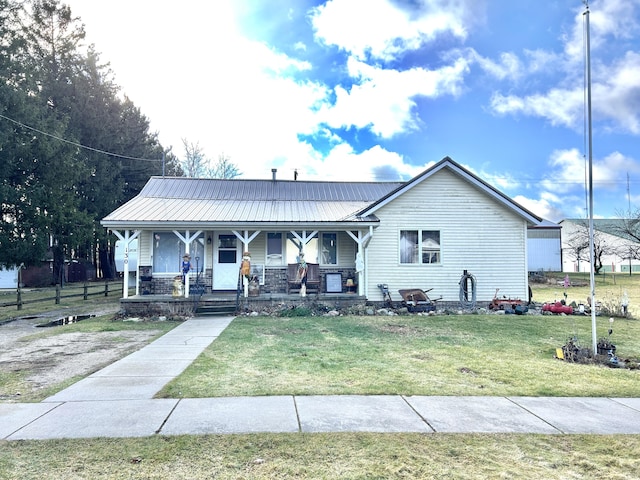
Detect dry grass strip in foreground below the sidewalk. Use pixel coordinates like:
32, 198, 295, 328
0, 433, 640, 480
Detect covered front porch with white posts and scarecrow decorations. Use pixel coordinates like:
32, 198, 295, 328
112, 228, 373, 299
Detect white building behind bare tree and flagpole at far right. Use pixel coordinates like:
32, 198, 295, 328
559, 218, 640, 273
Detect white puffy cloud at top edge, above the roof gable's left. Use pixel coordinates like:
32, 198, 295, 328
311, 0, 472, 61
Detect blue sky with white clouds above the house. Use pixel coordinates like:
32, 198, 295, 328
63, 0, 640, 222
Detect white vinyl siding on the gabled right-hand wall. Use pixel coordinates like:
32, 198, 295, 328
366, 170, 528, 301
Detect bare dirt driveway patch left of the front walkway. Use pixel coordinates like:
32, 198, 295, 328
0, 308, 158, 402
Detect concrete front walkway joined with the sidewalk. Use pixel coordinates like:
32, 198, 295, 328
0, 317, 640, 440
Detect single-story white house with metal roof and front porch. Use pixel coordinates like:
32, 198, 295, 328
102, 157, 542, 301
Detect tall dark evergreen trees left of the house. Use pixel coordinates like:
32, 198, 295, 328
0, 0, 239, 283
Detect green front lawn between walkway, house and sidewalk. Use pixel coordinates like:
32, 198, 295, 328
159, 314, 640, 398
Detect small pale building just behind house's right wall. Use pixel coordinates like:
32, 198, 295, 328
527, 220, 562, 272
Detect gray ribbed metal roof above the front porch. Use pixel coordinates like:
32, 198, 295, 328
102, 177, 402, 228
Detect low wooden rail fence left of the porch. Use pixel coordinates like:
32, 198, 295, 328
0, 280, 130, 310
